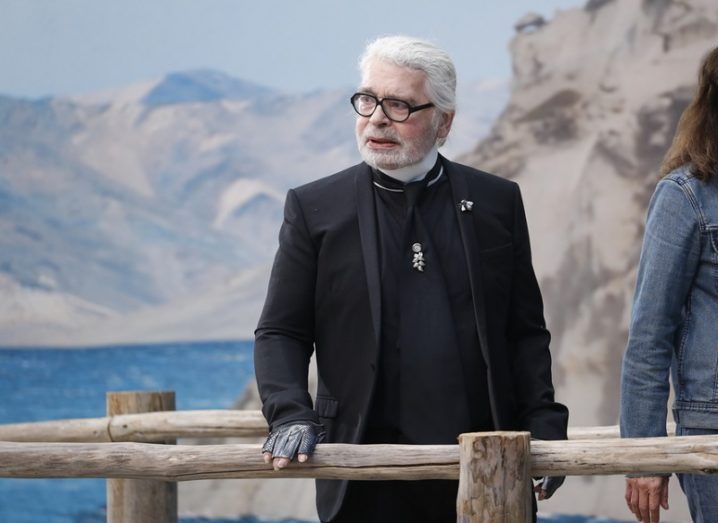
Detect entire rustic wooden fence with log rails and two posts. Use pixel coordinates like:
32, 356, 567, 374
0, 393, 718, 523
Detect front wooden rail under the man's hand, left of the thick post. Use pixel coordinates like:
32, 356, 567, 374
0, 442, 459, 481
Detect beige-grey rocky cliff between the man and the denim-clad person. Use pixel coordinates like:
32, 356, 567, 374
463, 0, 718, 521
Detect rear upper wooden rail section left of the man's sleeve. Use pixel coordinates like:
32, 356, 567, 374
0, 410, 267, 443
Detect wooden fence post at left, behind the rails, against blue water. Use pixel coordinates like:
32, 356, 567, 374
107, 391, 177, 523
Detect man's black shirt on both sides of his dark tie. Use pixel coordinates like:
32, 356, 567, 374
368, 159, 492, 442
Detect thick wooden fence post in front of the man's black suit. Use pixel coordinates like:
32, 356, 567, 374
456, 432, 533, 523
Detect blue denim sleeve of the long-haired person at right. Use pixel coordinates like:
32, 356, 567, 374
621, 179, 700, 437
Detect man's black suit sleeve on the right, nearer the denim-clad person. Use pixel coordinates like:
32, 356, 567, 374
508, 185, 568, 440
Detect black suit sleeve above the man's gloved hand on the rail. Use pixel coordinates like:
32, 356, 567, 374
254, 190, 319, 430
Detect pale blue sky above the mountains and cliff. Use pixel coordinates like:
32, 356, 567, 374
0, 0, 586, 98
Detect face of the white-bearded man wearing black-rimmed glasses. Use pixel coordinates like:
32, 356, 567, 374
355, 60, 453, 169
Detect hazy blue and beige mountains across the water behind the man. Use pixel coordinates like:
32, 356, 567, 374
0, 70, 508, 346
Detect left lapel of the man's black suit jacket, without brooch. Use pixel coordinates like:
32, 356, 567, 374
354, 164, 381, 347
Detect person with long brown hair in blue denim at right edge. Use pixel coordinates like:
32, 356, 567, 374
621, 48, 718, 522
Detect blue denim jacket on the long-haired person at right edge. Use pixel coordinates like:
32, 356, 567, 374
621, 166, 718, 437
